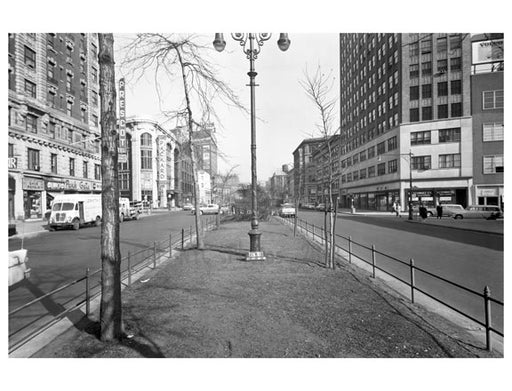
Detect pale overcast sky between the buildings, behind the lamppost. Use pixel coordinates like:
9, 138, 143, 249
115, 31, 339, 182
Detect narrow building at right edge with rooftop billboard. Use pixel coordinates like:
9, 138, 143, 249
471, 34, 505, 208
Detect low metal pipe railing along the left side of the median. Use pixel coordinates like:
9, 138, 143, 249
9, 217, 217, 353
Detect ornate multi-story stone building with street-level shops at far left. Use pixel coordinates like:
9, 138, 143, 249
8, 33, 101, 219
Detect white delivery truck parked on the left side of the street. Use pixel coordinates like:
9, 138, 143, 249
48, 194, 101, 231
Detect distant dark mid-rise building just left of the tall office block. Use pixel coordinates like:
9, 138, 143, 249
293, 137, 325, 205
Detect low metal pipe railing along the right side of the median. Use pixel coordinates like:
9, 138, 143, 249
281, 217, 504, 350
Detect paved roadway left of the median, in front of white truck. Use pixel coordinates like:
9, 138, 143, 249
9, 211, 212, 350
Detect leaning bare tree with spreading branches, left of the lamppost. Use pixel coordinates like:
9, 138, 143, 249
122, 33, 247, 249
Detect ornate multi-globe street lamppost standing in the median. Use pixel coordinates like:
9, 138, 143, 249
213, 33, 290, 261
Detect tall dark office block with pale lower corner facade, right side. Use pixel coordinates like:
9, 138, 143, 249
340, 33, 473, 210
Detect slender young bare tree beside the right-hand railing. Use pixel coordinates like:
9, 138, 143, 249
300, 65, 338, 268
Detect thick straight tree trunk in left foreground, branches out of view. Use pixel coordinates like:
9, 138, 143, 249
98, 34, 123, 341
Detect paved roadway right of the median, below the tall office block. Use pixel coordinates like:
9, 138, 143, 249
292, 211, 504, 330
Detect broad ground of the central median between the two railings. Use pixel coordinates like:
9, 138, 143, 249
29, 217, 493, 358
